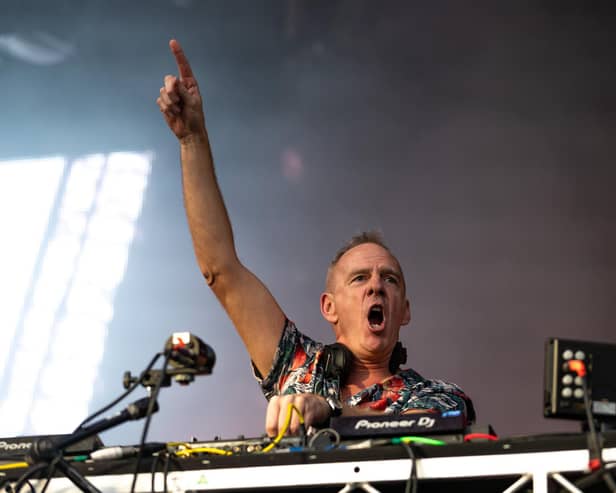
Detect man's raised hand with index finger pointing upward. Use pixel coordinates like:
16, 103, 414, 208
156, 39, 205, 140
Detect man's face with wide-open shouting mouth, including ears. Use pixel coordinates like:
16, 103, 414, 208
321, 243, 410, 363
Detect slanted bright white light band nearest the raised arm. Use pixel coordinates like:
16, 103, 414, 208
0, 153, 151, 436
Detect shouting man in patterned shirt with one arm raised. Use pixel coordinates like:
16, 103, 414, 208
157, 40, 474, 436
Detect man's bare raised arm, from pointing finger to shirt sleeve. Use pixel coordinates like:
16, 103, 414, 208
156, 40, 285, 376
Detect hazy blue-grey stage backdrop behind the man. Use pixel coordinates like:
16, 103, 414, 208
0, 0, 616, 444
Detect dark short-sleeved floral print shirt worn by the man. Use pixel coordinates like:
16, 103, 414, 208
254, 320, 475, 422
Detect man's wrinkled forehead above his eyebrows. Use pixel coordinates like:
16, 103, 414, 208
327, 243, 404, 288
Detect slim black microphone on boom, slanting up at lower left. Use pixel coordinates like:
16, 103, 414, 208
26, 397, 158, 464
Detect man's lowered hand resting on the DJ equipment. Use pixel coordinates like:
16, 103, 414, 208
265, 394, 331, 437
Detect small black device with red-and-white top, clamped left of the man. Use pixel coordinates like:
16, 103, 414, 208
165, 332, 216, 383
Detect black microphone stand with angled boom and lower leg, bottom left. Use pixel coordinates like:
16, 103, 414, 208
26, 397, 158, 493
